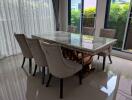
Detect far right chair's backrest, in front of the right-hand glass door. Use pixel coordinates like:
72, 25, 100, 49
100, 29, 116, 38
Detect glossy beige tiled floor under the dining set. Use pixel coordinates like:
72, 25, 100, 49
0, 55, 132, 100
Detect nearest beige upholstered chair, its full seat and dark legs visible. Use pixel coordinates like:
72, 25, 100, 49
41, 43, 82, 98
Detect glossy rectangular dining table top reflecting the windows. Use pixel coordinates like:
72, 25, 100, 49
32, 31, 117, 70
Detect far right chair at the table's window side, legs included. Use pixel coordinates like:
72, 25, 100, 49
98, 29, 116, 70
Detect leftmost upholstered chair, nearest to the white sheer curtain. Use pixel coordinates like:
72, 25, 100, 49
14, 34, 33, 73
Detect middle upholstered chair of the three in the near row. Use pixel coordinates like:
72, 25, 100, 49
26, 38, 48, 84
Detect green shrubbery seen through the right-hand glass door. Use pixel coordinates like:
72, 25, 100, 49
108, 3, 129, 48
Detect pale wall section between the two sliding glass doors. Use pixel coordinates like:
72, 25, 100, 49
95, 0, 107, 36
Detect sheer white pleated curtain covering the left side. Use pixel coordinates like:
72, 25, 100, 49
0, 0, 56, 58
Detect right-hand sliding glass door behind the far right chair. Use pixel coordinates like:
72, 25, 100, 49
105, 0, 130, 50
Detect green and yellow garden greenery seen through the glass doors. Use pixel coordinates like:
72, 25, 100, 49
71, 3, 129, 48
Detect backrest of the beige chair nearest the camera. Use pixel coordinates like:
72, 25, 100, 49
41, 42, 68, 78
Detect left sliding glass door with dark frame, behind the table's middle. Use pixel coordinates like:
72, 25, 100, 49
68, 0, 97, 33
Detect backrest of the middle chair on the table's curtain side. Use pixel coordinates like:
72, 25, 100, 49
26, 38, 47, 67
